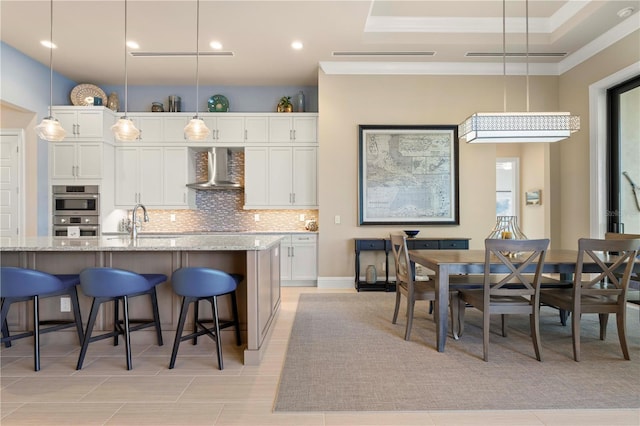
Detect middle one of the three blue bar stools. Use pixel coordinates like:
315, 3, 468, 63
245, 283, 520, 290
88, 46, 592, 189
76, 268, 167, 370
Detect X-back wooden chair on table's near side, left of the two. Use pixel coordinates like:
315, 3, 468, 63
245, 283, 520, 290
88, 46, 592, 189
458, 239, 549, 361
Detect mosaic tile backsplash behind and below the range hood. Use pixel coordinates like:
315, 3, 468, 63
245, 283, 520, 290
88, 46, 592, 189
134, 151, 318, 232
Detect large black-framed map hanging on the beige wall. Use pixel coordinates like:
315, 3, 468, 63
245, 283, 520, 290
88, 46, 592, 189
358, 124, 460, 225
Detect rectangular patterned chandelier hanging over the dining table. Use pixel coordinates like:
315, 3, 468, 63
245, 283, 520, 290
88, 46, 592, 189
458, 0, 580, 143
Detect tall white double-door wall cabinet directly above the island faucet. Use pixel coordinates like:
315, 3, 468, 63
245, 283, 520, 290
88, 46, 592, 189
115, 147, 163, 208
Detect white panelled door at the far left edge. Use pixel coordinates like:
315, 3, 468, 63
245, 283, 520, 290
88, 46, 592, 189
0, 130, 24, 238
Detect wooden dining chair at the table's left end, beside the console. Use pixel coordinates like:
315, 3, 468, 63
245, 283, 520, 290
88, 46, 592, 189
391, 234, 459, 340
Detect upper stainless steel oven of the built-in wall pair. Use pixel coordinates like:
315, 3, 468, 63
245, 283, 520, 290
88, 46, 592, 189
53, 185, 100, 216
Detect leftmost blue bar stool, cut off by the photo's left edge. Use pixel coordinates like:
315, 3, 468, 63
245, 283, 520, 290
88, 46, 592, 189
0, 266, 84, 371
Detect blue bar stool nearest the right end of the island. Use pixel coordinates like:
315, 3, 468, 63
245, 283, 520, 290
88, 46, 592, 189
169, 267, 244, 370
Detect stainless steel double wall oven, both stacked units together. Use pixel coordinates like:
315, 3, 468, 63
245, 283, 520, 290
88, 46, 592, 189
52, 185, 100, 237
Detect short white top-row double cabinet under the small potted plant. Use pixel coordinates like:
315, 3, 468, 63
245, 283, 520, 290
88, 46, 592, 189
269, 114, 318, 143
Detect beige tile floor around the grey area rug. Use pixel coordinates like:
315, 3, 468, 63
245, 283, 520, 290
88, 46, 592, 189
0, 287, 640, 426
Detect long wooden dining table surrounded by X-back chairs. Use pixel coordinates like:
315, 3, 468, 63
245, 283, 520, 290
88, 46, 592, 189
409, 249, 640, 352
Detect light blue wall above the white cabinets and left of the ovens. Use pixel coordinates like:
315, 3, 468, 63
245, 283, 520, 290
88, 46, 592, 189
0, 42, 318, 235
